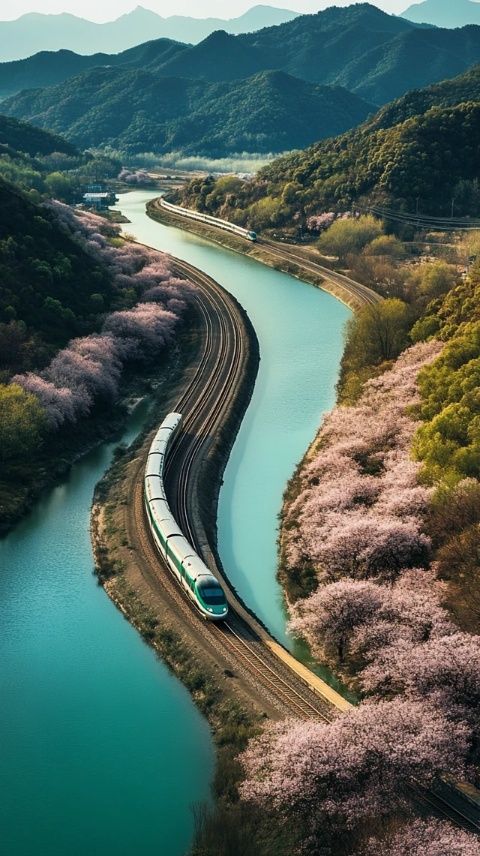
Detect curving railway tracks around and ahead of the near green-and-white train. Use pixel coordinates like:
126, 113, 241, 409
129, 260, 334, 719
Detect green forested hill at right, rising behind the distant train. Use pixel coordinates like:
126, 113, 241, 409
179, 67, 480, 228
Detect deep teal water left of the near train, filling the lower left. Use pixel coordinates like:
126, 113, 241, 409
0, 404, 214, 856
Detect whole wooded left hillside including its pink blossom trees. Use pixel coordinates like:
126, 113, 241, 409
0, 178, 190, 531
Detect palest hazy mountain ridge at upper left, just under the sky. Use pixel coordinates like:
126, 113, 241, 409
0, 6, 298, 62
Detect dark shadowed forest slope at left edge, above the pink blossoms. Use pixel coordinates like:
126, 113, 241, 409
0, 178, 113, 378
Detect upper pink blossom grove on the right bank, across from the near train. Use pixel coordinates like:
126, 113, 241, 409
284, 342, 441, 583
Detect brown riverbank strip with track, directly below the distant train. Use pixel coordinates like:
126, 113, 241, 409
147, 199, 380, 311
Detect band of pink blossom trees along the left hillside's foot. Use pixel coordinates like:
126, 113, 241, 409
14, 202, 194, 430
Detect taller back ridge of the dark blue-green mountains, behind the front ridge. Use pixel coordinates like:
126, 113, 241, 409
4, 3, 480, 108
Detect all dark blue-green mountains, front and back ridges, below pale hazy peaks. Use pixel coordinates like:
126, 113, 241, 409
6, 3, 480, 157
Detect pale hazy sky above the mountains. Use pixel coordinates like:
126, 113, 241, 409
0, 0, 410, 21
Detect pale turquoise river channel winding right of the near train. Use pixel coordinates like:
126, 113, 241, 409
117, 191, 351, 668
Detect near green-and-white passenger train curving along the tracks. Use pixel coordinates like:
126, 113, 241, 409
144, 413, 228, 621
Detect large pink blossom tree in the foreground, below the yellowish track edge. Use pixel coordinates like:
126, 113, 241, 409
241, 700, 468, 837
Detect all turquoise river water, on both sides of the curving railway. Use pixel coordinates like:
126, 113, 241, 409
0, 191, 349, 856
